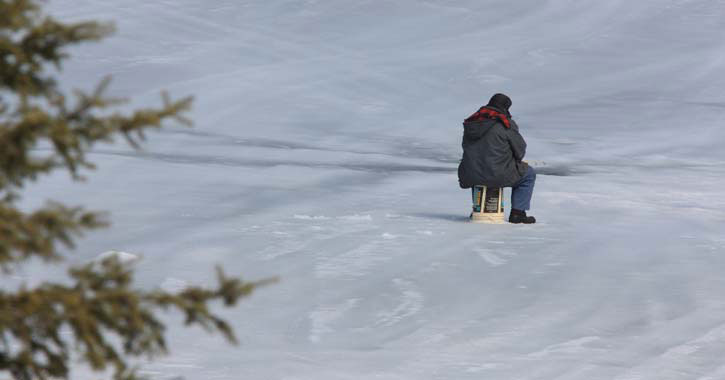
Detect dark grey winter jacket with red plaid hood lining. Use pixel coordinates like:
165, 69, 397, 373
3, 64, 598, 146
458, 106, 528, 189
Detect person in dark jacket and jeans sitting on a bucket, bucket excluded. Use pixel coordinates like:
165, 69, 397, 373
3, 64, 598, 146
458, 94, 536, 224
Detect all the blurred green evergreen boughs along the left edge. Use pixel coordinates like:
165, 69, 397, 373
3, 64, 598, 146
0, 0, 273, 380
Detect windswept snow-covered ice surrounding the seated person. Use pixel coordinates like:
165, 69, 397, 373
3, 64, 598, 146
12, 0, 725, 380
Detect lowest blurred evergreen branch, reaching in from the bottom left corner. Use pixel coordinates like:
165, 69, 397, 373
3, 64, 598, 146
0, 257, 274, 380
